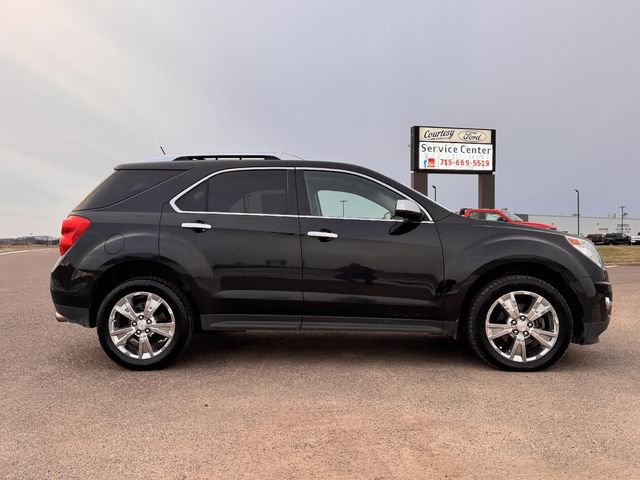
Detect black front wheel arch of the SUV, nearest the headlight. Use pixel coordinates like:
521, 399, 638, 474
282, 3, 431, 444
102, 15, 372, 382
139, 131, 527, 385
456, 261, 584, 338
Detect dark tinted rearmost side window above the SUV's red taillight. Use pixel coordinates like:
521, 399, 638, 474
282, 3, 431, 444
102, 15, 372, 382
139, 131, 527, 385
75, 170, 181, 210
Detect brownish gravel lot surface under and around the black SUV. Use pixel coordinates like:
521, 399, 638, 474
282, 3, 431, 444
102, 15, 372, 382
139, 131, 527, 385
0, 250, 640, 479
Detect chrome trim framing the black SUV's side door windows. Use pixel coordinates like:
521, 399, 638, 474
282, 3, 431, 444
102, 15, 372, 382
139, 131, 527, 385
169, 166, 433, 223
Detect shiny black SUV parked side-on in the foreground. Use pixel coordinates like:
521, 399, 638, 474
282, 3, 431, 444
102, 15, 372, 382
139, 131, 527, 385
51, 156, 612, 370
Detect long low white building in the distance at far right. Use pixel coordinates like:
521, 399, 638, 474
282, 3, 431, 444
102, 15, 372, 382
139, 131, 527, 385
517, 213, 640, 236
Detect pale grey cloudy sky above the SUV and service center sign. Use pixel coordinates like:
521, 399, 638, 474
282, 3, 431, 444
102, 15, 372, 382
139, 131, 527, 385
0, 0, 640, 237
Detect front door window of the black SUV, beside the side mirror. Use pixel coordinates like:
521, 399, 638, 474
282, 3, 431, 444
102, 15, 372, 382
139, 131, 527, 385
304, 170, 404, 220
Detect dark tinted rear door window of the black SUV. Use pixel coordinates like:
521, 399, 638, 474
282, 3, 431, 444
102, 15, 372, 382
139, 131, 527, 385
208, 170, 289, 214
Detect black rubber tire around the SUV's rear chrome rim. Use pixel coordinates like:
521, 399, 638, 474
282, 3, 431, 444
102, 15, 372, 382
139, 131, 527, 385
97, 277, 193, 370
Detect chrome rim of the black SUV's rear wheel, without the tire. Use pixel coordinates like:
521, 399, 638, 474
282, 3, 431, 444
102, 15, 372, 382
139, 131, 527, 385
109, 292, 176, 360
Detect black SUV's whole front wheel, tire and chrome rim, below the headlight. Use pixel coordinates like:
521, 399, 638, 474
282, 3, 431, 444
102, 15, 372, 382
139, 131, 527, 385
467, 275, 573, 371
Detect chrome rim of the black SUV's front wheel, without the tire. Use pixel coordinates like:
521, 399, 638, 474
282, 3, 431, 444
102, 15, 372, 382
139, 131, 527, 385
485, 290, 560, 362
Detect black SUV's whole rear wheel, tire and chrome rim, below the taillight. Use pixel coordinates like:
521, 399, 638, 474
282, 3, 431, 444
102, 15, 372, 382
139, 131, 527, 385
97, 278, 193, 370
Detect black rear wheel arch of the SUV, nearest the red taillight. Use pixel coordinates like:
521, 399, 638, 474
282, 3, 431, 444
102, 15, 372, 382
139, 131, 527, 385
89, 260, 200, 327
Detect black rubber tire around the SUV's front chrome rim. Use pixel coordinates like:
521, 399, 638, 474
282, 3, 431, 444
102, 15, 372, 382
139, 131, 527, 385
466, 275, 573, 371
